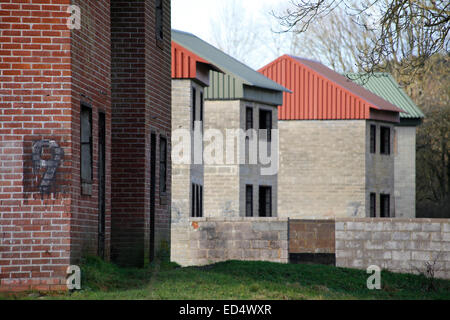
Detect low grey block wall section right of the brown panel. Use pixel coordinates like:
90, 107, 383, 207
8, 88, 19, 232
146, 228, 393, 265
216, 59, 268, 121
335, 218, 450, 279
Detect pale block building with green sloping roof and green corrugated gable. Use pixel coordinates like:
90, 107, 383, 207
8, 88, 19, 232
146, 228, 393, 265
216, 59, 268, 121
172, 30, 286, 218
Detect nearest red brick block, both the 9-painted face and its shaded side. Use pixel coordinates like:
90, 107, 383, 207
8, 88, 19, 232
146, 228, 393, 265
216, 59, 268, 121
0, 0, 110, 290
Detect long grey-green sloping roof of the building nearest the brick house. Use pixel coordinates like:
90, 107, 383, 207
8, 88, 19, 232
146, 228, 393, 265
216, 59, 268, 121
172, 29, 289, 98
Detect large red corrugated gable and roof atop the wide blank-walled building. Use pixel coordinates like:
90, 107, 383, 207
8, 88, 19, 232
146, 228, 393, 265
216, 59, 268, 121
259, 55, 403, 120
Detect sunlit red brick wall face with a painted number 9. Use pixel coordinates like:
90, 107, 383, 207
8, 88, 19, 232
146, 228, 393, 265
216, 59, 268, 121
0, 0, 74, 290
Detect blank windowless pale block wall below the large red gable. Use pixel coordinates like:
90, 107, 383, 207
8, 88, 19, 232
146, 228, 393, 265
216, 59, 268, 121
278, 120, 366, 219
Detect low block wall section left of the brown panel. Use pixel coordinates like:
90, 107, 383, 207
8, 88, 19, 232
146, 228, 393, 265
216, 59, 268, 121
171, 218, 288, 266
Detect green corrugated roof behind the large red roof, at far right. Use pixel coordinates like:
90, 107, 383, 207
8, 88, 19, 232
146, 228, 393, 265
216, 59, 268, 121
346, 72, 424, 119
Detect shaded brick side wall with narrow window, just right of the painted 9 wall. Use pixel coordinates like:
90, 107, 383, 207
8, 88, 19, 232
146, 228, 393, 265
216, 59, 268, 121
70, 0, 111, 264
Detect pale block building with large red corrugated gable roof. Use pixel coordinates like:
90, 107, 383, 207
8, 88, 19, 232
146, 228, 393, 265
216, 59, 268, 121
259, 55, 403, 218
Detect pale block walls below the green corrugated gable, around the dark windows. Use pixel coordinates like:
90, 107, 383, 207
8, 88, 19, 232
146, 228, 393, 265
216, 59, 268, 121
204, 100, 278, 217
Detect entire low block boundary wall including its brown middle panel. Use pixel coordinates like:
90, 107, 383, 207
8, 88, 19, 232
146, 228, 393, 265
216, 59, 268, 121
171, 218, 450, 279
